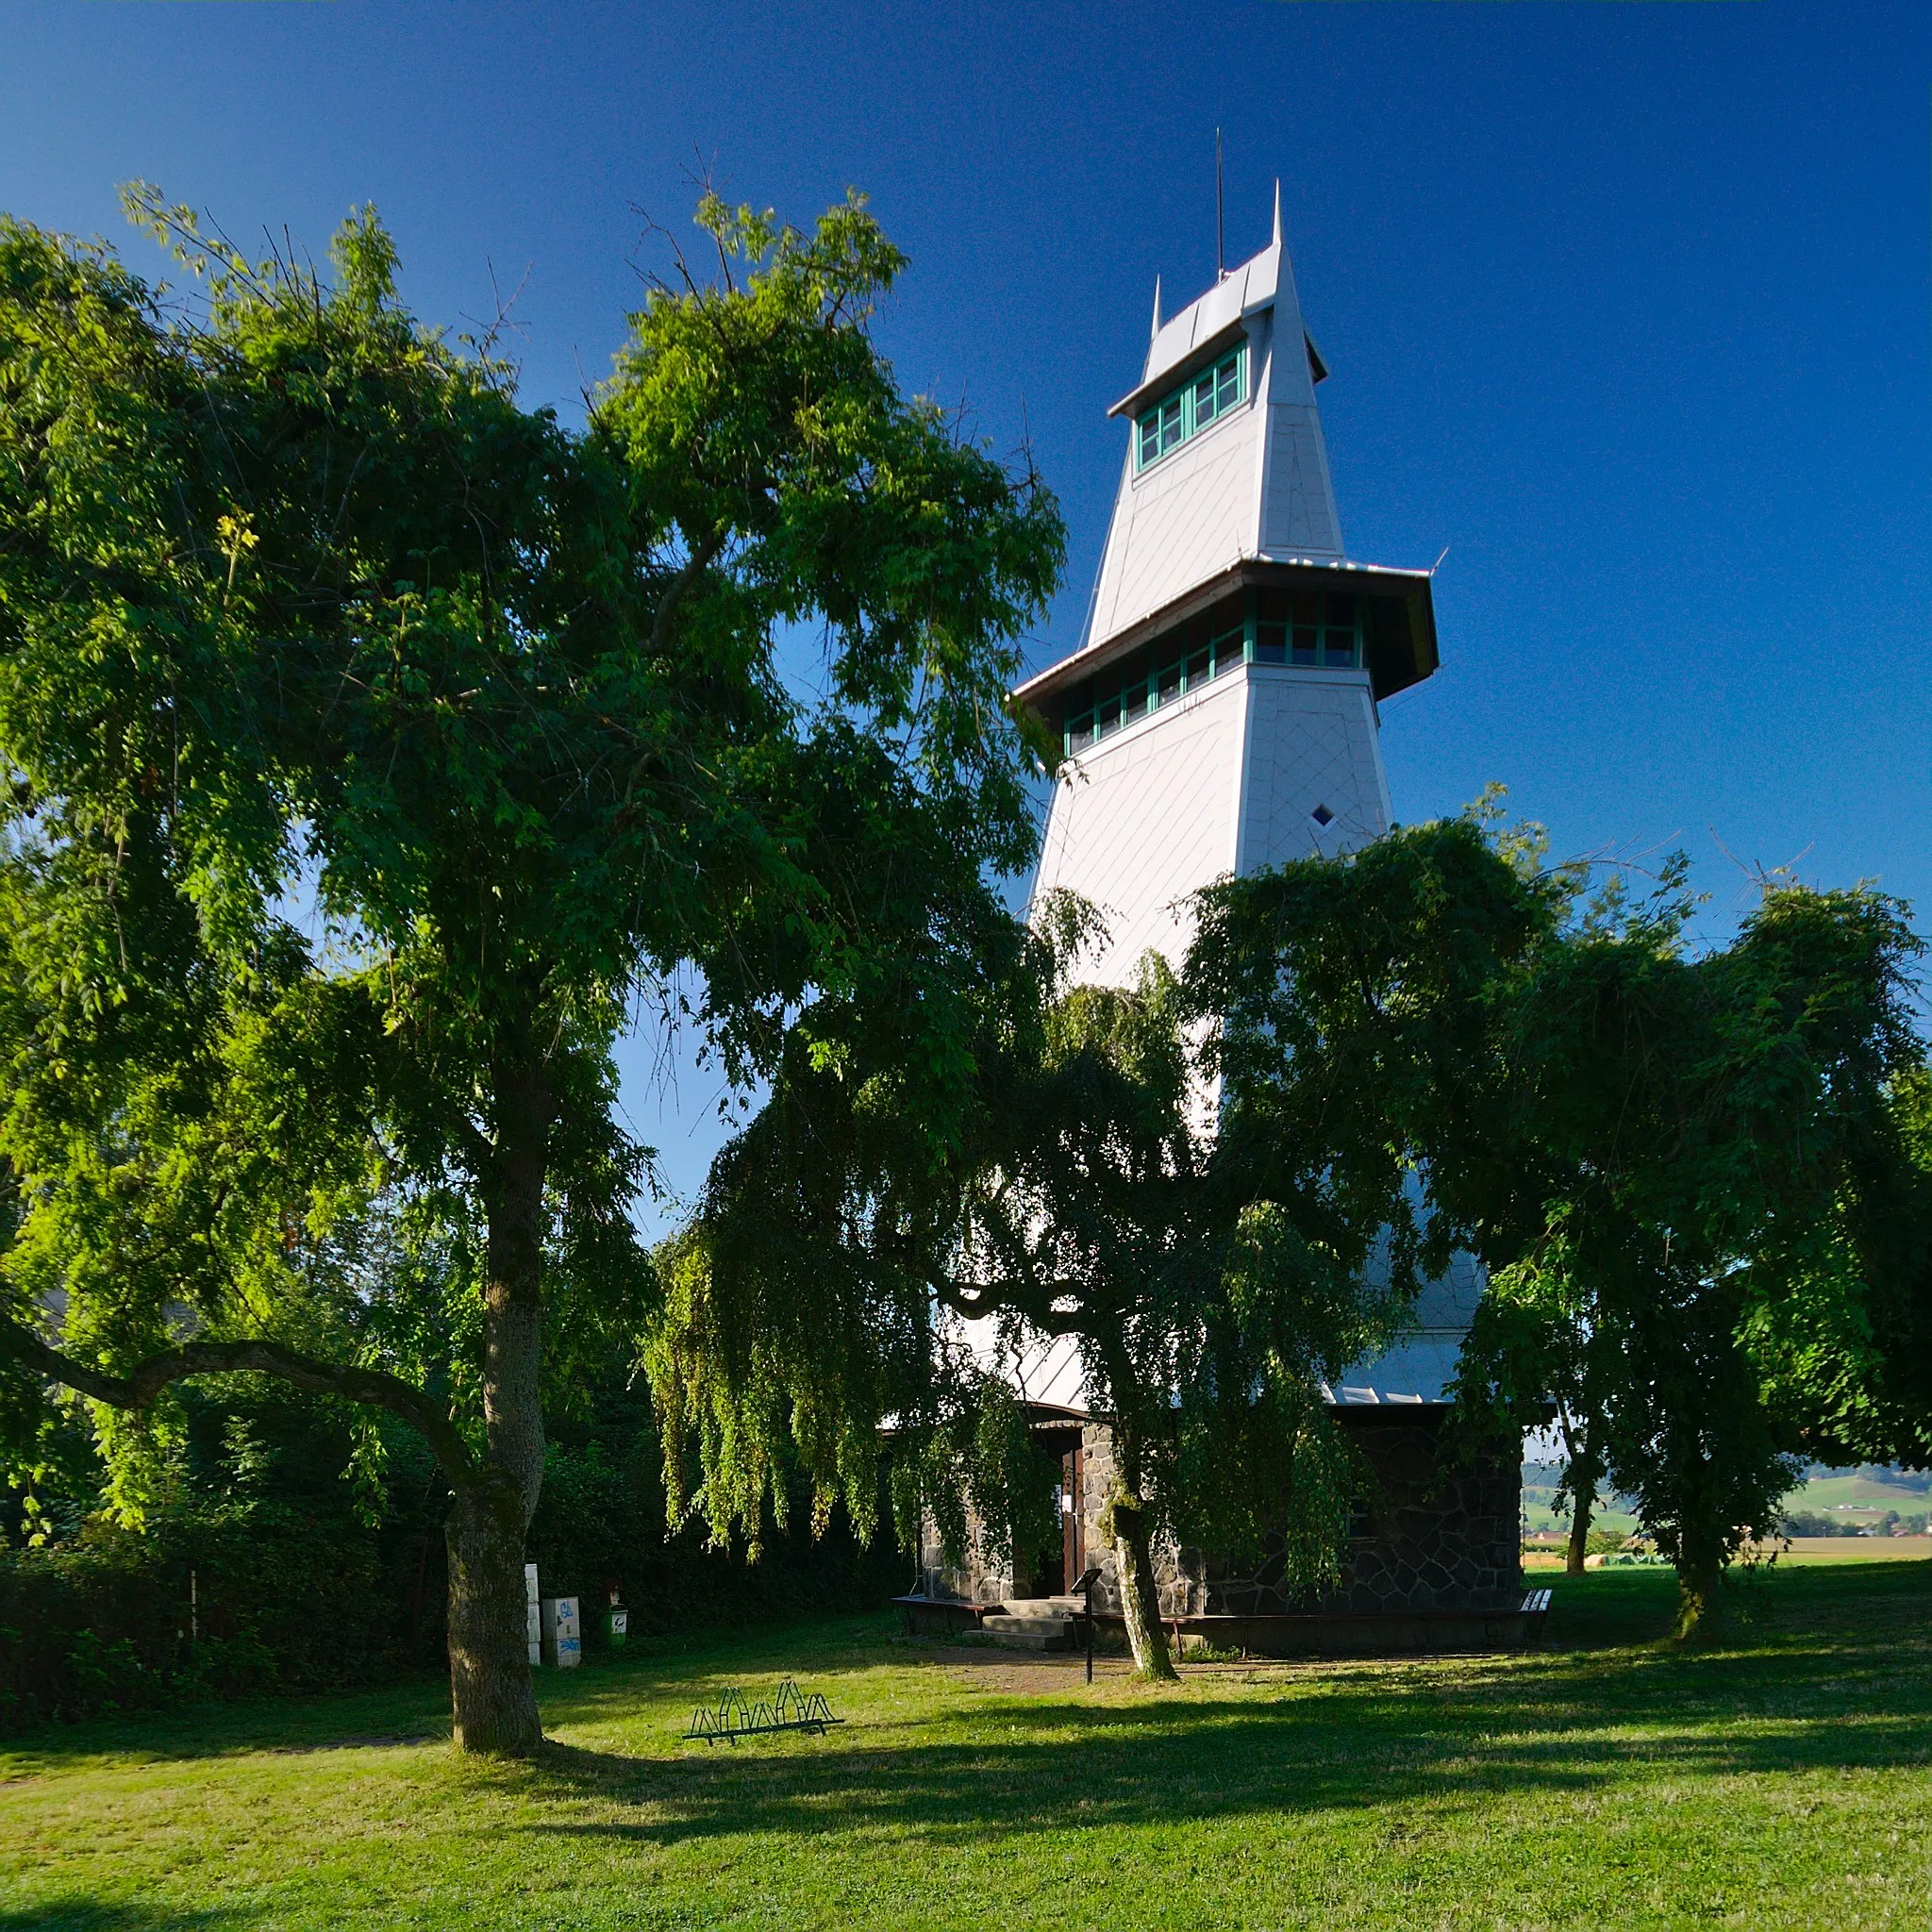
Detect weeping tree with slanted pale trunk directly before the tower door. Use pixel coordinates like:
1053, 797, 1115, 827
651, 902, 1422, 1675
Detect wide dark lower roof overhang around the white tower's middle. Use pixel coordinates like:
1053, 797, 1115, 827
1012, 557, 1441, 715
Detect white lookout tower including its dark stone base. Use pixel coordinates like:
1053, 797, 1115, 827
927, 190, 1530, 1654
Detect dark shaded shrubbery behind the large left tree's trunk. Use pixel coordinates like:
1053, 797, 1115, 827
0, 1355, 904, 1731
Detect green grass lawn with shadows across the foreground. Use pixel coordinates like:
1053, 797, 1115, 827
0, 1563, 1932, 1932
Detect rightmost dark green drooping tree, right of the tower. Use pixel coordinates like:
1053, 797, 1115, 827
1468, 881, 1924, 1639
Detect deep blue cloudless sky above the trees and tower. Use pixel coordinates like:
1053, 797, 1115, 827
0, 0, 1932, 1205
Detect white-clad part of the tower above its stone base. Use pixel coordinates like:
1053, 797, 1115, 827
1014, 199, 1480, 1407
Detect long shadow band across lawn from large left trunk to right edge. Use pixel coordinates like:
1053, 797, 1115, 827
518, 1592, 1932, 1847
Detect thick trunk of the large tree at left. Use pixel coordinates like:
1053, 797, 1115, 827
448, 1069, 549, 1758
